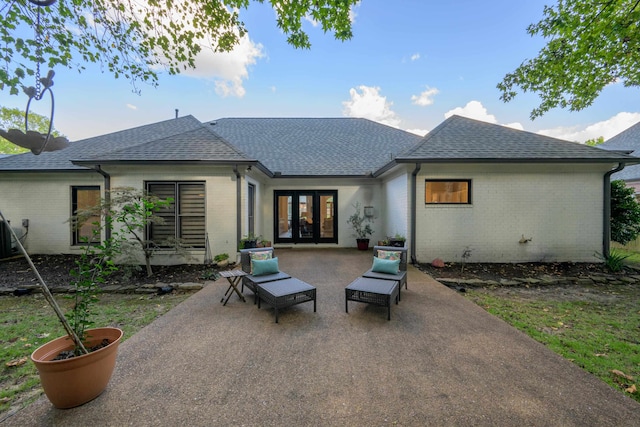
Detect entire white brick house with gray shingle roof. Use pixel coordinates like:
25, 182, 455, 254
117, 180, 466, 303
0, 116, 640, 263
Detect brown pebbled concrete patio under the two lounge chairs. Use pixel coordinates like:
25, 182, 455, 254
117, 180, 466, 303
4, 249, 640, 426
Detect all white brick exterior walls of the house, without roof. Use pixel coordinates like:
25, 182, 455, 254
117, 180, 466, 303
0, 164, 610, 263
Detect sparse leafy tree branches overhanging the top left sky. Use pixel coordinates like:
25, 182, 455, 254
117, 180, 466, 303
0, 0, 358, 94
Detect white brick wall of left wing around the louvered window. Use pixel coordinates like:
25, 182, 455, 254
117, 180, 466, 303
0, 166, 237, 264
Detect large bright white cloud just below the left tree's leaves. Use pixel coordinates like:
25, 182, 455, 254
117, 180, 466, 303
182, 35, 265, 98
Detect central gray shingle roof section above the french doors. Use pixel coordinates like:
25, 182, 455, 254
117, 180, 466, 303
209, 118, 421, 176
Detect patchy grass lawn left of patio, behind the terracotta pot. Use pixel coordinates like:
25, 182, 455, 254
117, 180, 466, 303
0, 293, 191, 423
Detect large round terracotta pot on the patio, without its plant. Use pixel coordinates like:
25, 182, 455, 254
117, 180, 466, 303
31, 328, 123, 409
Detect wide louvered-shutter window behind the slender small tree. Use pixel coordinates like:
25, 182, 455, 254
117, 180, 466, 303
147, 181, 205, 248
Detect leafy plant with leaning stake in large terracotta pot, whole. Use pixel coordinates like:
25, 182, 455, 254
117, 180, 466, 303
0, 212, 123, 409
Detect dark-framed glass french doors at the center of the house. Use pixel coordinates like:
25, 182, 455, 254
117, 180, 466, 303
273, 190, 338, 243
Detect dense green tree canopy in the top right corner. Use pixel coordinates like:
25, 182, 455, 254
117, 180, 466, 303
498, 0, 640, 119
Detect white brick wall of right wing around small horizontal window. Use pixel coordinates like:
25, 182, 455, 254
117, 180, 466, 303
416, 165, 606, 262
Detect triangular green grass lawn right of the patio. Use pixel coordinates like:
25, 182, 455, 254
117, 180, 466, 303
465, 284, 640, 402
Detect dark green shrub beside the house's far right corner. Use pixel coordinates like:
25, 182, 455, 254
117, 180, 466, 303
611, 180, 640, 245
